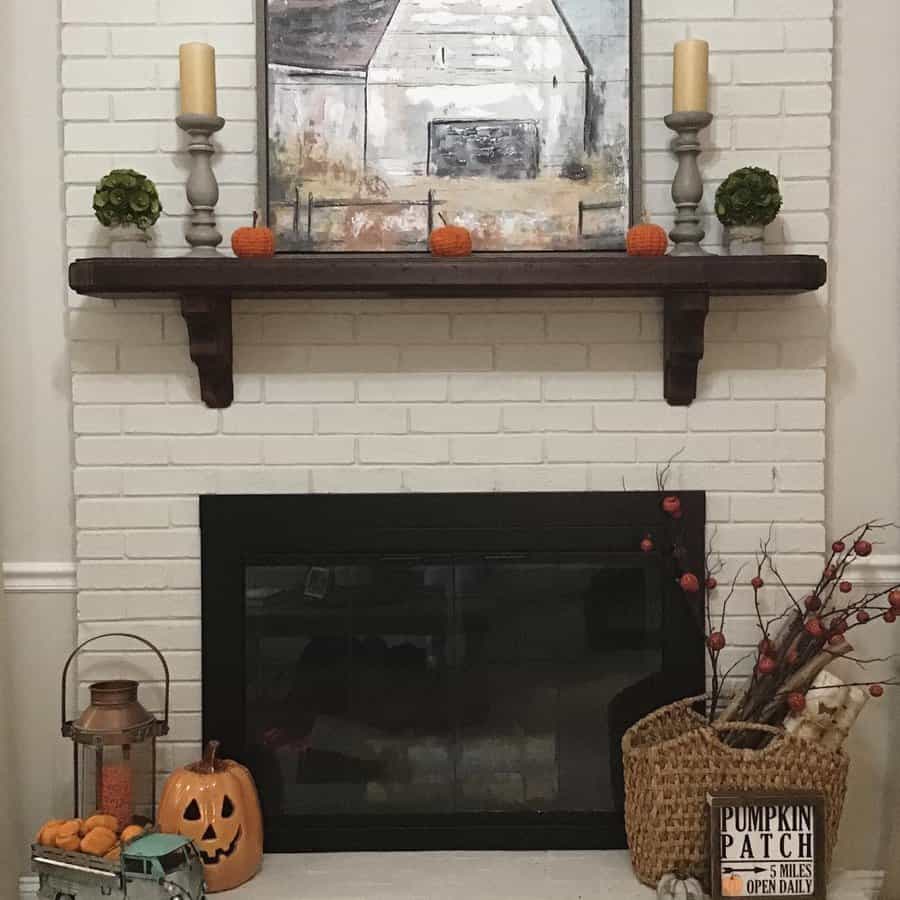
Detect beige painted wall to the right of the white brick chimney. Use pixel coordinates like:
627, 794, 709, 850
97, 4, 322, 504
826, 0, 900, 880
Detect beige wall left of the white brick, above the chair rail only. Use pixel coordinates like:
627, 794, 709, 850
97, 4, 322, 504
0, 0, 72, 562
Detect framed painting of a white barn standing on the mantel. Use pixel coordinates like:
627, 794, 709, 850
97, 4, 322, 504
256, 0, 642, 253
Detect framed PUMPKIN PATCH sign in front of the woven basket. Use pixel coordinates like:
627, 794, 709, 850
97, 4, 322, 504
707, 790, 826, 900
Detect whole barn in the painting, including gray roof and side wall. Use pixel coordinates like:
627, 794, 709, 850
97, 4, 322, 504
269, 0, 592, 182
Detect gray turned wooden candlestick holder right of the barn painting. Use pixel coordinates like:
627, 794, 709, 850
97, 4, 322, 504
665, 111, 713, 256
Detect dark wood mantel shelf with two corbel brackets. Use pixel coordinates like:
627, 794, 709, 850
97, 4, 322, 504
69, 253, 826, 408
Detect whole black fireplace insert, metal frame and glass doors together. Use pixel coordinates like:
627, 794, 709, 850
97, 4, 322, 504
200, 492, 706, 852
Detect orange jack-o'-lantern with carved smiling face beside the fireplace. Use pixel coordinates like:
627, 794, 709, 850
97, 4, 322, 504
159, 741, 263, 893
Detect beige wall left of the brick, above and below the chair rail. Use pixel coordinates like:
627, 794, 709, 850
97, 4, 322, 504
0, 0, 74, 880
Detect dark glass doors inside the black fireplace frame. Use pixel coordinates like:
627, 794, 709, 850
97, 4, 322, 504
246, 556, 665, 828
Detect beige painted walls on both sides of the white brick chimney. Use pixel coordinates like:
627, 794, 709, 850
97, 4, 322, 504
0, 0, 900, 884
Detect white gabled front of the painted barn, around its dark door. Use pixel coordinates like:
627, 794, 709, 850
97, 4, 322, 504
368, 0, 590, 175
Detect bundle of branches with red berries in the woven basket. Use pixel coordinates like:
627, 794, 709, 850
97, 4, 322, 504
641, 467, 900, 748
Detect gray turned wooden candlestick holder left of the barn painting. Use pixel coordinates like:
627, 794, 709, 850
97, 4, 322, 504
175, 113, 225, 256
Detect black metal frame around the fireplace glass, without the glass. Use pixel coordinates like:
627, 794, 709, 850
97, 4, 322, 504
200, 491, 706, 853
